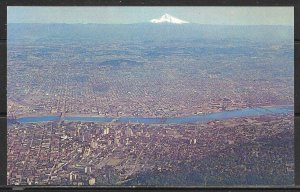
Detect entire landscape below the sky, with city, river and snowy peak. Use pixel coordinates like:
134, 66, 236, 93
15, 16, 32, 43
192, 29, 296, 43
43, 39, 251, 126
7, 9, 294, 186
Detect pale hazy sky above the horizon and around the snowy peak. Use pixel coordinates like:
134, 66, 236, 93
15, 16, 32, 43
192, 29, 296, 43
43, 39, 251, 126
7, 6, 294, 26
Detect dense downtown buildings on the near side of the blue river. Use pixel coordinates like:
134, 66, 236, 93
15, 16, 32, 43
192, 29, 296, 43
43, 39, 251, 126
7, 115, 293, 185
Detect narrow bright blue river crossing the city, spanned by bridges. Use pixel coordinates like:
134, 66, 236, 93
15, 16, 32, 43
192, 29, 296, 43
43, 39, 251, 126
17, 106, 294, 124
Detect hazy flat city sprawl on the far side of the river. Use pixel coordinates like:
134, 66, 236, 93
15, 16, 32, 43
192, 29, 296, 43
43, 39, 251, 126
7, 38, 294, 117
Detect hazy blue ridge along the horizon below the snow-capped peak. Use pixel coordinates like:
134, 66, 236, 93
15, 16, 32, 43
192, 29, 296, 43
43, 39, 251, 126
7, 23, 294, 42
